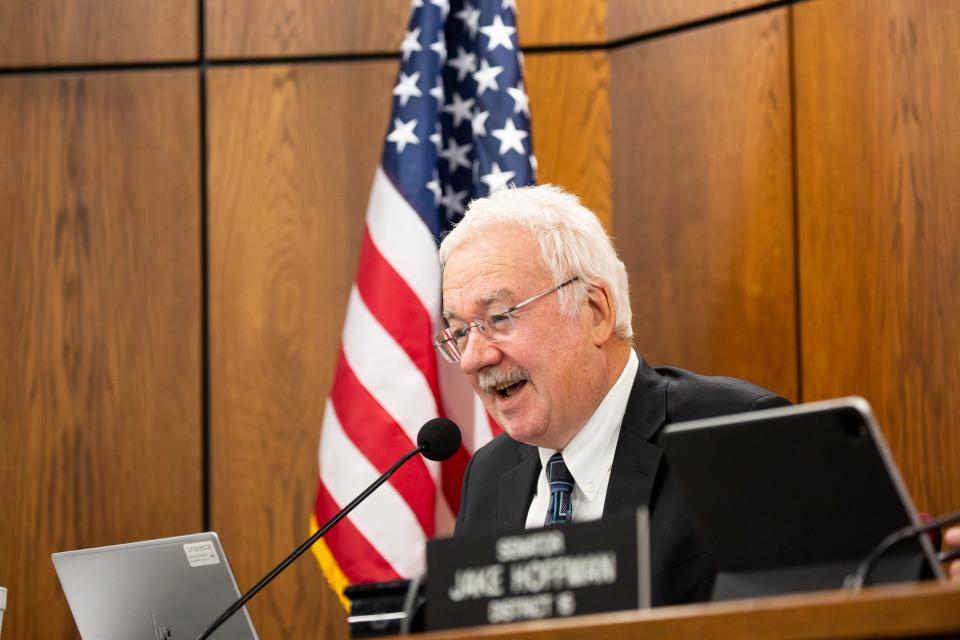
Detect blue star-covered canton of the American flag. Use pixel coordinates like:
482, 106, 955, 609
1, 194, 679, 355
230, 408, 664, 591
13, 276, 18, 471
383, 0, 536, 242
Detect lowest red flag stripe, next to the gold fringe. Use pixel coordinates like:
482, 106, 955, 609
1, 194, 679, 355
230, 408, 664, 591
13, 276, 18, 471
313, 480, 400, 584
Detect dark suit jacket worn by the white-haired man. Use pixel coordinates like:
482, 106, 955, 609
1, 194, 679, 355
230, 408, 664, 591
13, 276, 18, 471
454, 360, 789, 606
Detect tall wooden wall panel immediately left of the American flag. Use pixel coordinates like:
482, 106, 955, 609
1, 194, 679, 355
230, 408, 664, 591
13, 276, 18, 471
209, 62, 397, 638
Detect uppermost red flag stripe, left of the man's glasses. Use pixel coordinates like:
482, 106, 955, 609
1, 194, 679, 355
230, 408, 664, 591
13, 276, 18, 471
357, 227, 440, 407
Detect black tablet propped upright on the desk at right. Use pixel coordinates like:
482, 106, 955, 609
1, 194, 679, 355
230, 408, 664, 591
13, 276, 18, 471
658, 398, 943, 600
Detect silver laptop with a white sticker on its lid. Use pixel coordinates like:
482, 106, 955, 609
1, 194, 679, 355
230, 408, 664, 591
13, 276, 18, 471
52, 532, 257, 640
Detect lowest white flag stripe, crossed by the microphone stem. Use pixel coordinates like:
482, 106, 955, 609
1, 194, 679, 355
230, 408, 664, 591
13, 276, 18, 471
320, 401, 426, 578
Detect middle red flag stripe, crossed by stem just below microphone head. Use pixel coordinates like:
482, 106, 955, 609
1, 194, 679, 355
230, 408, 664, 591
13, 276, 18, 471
330, 351, 436, 537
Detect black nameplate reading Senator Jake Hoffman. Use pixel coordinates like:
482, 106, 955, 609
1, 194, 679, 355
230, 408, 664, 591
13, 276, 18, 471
426, 508, 650, 630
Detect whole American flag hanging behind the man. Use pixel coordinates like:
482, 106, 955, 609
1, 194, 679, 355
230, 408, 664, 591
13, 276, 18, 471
311, 0, 536, 605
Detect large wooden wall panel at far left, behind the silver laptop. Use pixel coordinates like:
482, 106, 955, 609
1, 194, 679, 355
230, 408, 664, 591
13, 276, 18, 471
0, 71, 202, 638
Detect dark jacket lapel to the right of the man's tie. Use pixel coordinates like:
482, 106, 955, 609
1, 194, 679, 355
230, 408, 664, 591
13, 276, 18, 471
603, 360, 667, 515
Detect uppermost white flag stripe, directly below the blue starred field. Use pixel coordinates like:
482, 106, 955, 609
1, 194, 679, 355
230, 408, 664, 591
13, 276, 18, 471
367, 167, 440, 318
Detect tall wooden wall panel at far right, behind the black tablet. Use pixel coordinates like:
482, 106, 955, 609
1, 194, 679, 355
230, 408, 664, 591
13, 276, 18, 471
795, 0, 960, 512
